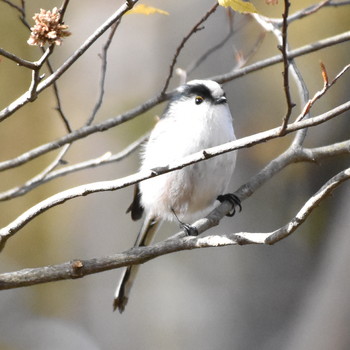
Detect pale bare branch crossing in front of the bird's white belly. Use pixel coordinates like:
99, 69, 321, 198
0, 101, 350, 249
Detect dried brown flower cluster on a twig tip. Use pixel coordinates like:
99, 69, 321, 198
27, 7, 71, 46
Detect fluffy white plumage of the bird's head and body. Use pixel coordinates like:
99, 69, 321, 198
140, 80, 236, 223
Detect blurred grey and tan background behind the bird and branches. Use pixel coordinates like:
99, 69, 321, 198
0, 0, 350, 350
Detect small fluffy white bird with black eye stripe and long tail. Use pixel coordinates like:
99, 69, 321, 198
113, 80, 241, 312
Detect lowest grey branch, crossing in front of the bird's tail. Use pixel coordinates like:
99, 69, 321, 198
0, 168, 350, 290
